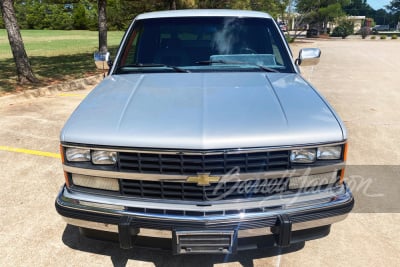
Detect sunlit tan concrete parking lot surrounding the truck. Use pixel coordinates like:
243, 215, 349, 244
0, 38, 400, 266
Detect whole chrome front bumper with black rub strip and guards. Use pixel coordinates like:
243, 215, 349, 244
56, 184, 354, 254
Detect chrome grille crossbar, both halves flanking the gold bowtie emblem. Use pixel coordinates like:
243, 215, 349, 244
63, 162, 345, 182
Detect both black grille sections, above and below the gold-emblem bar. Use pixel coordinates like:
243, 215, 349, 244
118, 150, 290, 201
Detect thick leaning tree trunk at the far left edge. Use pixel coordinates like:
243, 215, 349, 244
0, 0, 38, 84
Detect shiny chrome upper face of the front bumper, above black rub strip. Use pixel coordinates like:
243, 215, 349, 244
56, 184, 353, 225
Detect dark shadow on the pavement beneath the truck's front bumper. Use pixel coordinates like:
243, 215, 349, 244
62, 225, 305, 266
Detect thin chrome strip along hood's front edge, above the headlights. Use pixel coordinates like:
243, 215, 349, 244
61, 140, 347, 155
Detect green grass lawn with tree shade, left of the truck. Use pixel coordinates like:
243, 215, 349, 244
0, 29, 123, 94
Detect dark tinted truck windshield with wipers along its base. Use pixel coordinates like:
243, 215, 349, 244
114, 17, 294, 74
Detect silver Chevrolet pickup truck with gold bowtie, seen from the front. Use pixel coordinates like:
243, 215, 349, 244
56, 10, 354, 254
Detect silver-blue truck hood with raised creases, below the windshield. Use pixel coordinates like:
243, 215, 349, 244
61, 72, 346, 149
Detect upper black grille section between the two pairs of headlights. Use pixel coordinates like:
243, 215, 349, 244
119, 151, 289, 175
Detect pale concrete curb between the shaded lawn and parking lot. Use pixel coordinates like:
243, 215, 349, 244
0, 74, 103, 106
